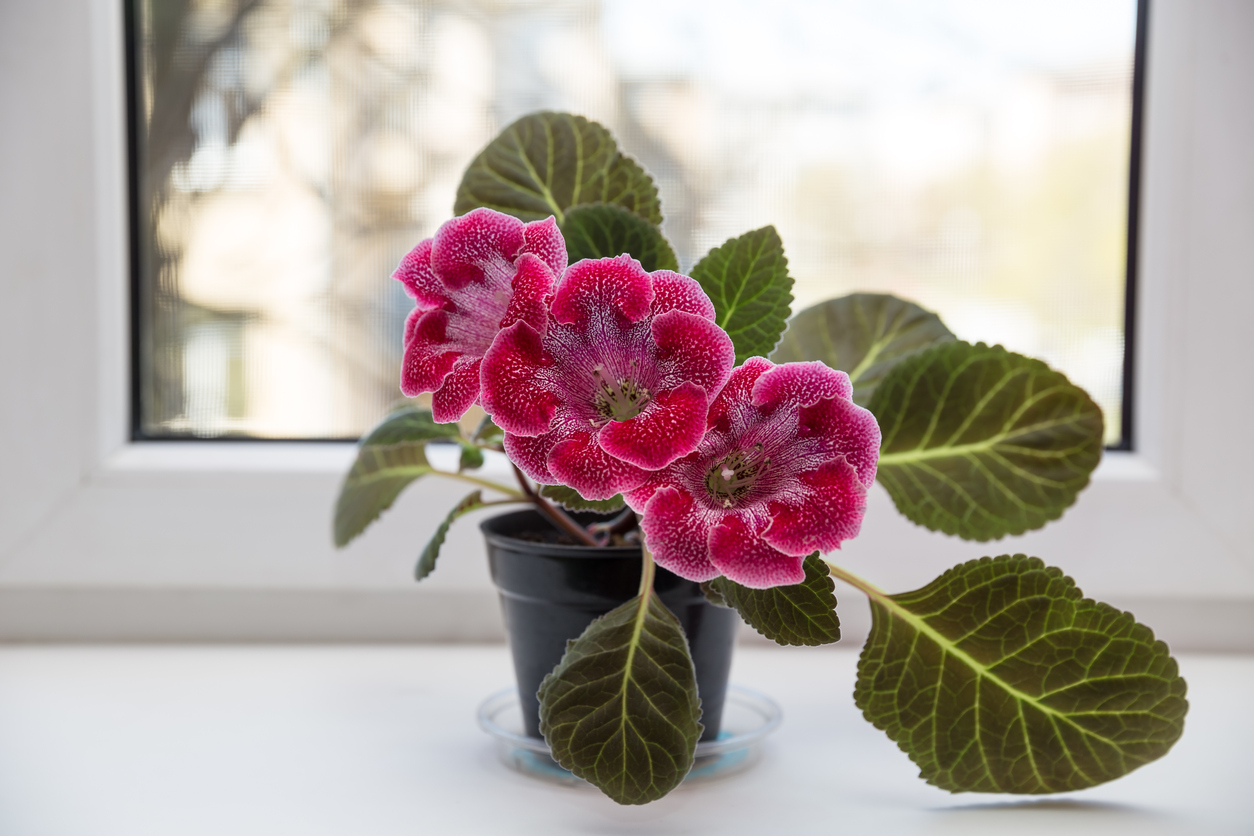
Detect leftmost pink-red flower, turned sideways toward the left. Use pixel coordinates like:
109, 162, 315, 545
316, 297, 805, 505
393, 209, 566, 424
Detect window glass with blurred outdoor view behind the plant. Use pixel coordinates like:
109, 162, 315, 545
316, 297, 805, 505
130, 0, 1136, 442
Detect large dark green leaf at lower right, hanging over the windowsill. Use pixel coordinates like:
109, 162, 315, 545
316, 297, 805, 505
854, 554, 1189, 793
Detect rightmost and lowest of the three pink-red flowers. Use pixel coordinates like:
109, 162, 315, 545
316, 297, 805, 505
626, 357, 880, 589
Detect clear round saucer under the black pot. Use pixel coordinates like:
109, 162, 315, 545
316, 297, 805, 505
478, 686, 782, 787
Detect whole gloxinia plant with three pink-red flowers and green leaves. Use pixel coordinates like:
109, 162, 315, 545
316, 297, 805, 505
335, 113, 1188, 803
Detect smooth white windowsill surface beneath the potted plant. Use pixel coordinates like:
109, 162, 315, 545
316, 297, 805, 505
0, 645, 1254, 836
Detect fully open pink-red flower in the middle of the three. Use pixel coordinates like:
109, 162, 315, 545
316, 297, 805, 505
483, 256, 735, 499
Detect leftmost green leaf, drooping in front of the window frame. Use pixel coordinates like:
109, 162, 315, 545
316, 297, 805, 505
334, 406, 459, 546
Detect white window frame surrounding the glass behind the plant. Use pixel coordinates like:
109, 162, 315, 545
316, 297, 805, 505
0, 0, 1254, 651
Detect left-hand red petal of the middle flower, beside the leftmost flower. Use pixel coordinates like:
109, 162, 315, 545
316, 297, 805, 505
479, 322, 559, 438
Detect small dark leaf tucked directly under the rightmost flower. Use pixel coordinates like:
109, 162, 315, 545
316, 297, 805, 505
701, 551, 840, 647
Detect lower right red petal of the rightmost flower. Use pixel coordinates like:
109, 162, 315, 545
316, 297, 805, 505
762, 459, 867, 558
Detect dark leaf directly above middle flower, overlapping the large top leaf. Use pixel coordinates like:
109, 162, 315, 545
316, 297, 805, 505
562, 203, 680, 273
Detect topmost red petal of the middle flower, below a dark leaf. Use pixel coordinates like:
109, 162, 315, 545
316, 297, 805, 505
553, 256, 653, 327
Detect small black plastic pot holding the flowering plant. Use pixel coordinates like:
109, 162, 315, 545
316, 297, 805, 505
479, 510, 740, 739
